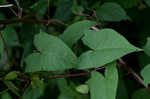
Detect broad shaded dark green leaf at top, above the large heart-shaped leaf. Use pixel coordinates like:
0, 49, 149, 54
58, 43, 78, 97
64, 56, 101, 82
96, 3, 129, 21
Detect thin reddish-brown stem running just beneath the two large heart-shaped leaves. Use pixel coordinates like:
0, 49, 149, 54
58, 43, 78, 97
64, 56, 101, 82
41, 66, 105, 79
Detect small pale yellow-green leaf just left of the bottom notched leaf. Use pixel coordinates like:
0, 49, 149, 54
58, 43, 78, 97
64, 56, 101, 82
76, 84, 89, 94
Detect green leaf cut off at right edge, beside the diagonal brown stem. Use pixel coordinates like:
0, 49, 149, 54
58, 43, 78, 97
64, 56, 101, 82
141, 64, 150, 86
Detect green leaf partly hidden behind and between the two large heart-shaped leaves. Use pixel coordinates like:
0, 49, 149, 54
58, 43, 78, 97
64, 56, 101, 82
60, 20, 96, 47
